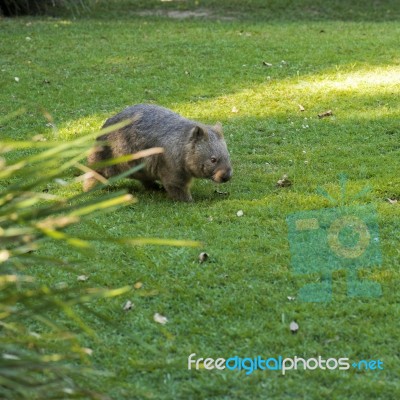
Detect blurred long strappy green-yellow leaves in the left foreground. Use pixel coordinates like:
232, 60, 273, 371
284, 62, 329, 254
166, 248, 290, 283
0, 118, 194, 399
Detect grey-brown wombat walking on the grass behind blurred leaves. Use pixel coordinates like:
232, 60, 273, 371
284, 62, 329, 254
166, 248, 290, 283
84, 104, 232, 201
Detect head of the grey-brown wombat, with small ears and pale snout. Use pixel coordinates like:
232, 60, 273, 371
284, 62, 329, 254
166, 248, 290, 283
186, 123, 232, 183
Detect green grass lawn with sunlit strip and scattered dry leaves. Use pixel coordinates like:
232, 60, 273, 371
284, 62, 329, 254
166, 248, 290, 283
0, 0, 400, 399
